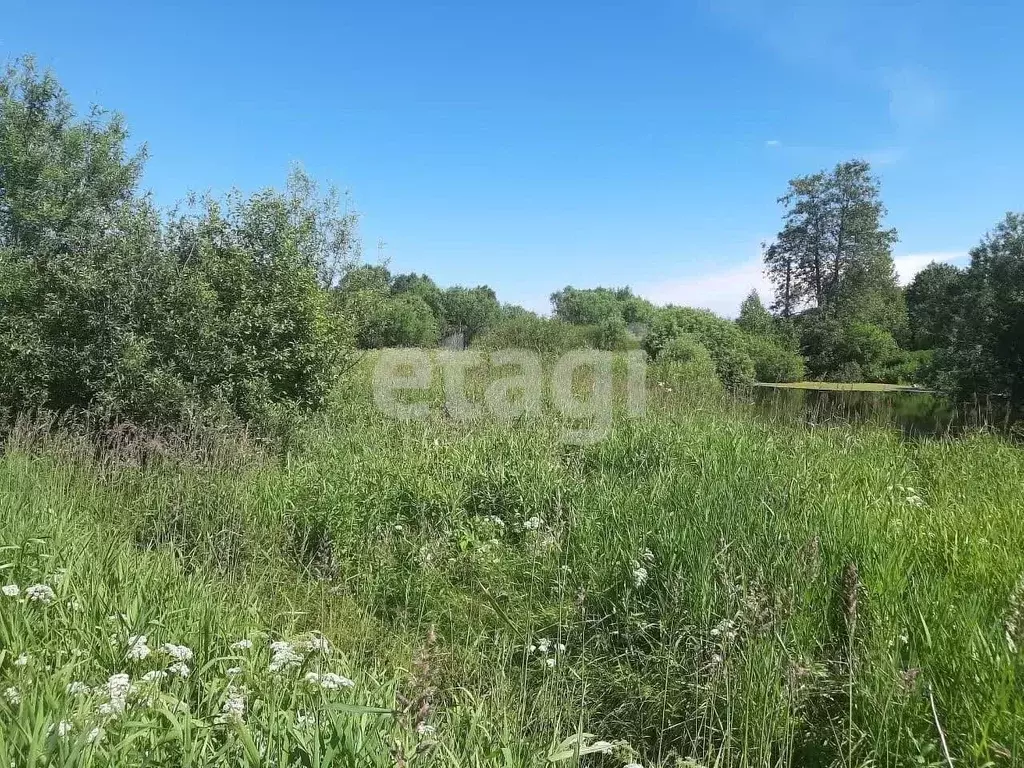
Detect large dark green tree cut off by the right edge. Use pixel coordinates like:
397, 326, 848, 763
935, 213, 1024, 408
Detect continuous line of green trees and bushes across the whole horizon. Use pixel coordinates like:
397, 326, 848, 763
0, 59, 1024, 434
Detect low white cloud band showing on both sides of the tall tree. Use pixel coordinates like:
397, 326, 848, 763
636, 251, 966, 317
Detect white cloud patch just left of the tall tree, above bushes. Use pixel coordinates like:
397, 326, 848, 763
636, 259, 772, 317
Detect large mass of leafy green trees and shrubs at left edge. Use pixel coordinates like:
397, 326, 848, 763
0, 62, 353, 425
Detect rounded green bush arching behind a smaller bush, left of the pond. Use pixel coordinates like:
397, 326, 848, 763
643, 306, 754, 386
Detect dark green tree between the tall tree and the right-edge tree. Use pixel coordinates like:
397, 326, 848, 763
906, 261, 965, 349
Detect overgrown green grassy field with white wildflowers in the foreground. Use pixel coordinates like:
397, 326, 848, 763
0, 359, 1024, 768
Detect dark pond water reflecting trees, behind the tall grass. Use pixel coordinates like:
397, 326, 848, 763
751, 386, 1011, 437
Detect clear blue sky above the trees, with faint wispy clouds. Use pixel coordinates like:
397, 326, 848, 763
0, 0, 1024, 312
